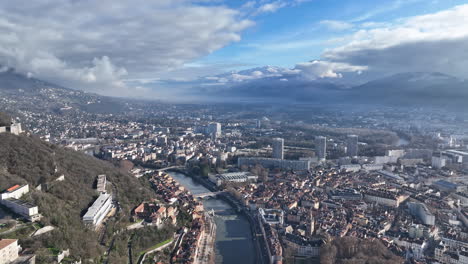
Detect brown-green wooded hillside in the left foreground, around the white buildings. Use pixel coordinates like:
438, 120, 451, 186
0, 133, 157, 263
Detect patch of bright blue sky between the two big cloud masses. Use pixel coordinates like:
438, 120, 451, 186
196, 0, 468, 69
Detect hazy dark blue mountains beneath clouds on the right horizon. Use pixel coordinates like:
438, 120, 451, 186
198, 71, 468, 108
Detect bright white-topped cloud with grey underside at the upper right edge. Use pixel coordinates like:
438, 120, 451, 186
322, 5, 468, 78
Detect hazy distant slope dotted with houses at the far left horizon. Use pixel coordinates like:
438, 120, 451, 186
0, 69, 126, 113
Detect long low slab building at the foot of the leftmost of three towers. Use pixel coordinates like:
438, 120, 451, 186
237, 157, 310, 171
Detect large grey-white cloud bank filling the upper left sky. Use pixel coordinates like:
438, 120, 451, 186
0, 0, 253, 94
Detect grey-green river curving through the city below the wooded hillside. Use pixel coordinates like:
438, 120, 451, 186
168, 172, 256, 264
